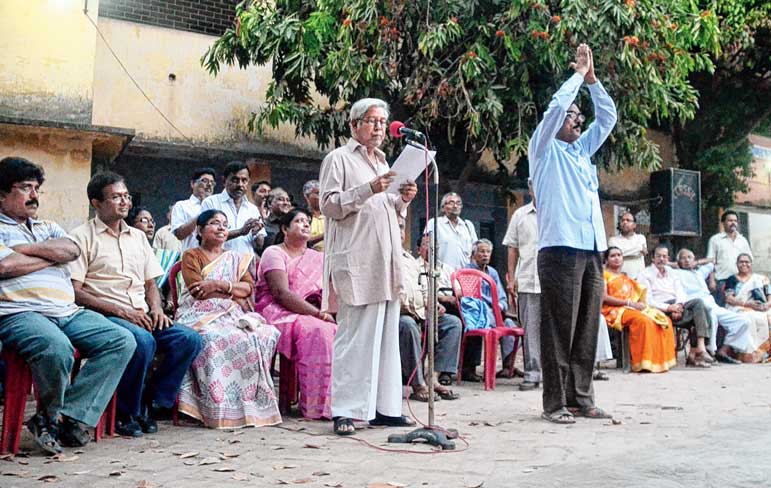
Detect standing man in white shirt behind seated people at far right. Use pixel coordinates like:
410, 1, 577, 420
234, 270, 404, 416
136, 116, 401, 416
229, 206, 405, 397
707, 210, 753, 305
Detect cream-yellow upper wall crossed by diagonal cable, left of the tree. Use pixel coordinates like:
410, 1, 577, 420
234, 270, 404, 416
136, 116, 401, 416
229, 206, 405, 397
93, 17, 316, 151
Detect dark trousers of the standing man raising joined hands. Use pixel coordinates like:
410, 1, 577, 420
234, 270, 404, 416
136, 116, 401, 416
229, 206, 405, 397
538, 246, 604, 413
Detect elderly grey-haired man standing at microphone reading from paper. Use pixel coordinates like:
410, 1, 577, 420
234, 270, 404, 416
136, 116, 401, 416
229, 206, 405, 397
319, 98, 417, 435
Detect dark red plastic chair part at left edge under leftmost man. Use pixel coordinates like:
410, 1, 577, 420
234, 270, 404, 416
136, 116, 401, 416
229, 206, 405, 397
0, 349, 32, 454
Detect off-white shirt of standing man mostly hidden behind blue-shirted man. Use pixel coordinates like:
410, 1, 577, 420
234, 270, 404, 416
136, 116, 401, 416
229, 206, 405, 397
503, 203, 541, 293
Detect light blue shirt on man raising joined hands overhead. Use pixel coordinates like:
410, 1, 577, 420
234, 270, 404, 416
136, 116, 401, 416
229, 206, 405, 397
528, 73, 616, 251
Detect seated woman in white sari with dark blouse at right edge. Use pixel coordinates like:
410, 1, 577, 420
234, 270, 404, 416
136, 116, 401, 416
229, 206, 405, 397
725, 253, 771, 352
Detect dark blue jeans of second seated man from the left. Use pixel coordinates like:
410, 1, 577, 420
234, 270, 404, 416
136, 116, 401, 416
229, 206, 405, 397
108, 317, 203, 417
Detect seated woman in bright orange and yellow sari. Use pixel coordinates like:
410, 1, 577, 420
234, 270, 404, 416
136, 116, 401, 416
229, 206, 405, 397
602, 246, 677, 373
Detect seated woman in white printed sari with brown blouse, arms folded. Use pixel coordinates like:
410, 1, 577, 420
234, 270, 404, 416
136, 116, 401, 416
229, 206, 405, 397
176, 210, 281, 429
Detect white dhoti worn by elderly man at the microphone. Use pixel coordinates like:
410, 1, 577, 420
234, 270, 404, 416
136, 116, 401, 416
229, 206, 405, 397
332, 300, 402, 420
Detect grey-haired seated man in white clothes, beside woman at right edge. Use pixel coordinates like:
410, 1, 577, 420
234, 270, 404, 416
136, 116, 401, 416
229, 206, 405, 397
676, 248, 763, 364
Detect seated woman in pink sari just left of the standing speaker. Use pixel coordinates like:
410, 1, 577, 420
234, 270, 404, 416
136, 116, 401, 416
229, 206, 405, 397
255, 209, 337, 419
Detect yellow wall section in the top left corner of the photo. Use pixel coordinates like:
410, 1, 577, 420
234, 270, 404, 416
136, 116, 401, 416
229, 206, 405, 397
0, 0, 99, 123
